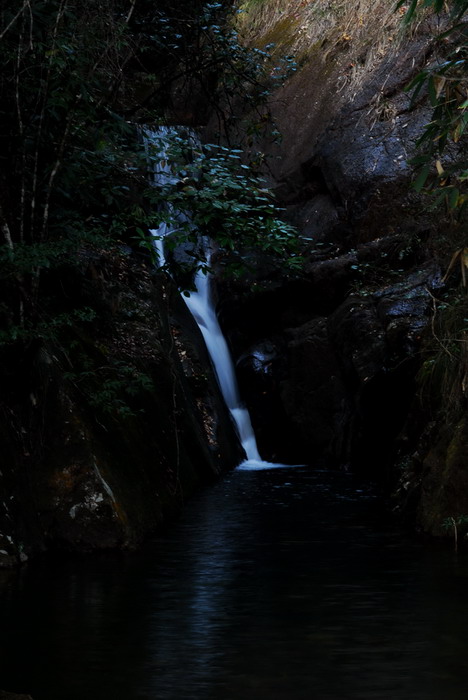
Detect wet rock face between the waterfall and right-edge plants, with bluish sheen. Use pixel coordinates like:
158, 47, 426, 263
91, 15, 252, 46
220, 26, 440, 479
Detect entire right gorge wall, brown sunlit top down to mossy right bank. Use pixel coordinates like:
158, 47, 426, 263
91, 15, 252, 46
216, 5, 468, 535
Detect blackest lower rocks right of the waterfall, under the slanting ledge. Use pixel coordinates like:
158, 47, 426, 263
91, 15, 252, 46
221, 256, 438, 470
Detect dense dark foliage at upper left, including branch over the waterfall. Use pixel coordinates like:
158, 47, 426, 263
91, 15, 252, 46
0, 0, 293, 416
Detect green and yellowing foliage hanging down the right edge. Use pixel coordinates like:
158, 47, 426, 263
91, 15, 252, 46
399, 0, 468, 438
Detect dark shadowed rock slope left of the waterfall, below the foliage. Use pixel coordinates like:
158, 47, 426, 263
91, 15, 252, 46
0, 253, 242, 566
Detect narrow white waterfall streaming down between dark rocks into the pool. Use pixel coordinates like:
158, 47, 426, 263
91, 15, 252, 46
143, 127, 264, 468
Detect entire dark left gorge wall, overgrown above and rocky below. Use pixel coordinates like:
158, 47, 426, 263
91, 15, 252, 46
0, 0, 249, 566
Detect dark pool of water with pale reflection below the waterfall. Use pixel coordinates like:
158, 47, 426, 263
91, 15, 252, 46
0, 467, 468, 700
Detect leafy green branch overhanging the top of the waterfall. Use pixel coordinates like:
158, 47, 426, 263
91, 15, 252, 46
142, 134, 302, 276
